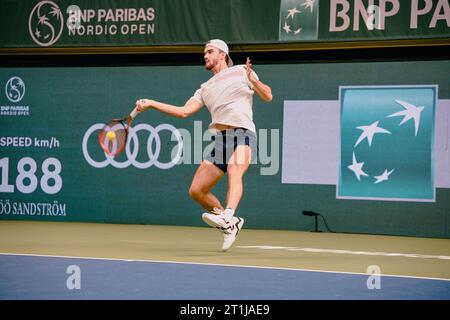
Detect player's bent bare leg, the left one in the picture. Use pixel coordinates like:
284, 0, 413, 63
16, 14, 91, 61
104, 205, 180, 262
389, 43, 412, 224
189, 160, 224, 212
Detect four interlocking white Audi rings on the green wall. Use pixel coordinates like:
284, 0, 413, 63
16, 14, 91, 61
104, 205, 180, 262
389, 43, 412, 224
82, 123, 183, 169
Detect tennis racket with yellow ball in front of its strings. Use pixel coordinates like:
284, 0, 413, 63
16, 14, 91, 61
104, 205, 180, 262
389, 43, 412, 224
98, 108, 139, 157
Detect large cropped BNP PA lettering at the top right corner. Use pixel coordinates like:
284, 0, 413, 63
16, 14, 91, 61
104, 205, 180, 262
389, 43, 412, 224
329, 0, 450, 32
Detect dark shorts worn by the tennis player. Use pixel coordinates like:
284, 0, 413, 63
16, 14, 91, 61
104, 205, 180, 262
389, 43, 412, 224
205, 128, 258, 173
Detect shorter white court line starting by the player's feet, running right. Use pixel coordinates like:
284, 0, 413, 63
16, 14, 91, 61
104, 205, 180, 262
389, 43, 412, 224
237, 245, 450, 260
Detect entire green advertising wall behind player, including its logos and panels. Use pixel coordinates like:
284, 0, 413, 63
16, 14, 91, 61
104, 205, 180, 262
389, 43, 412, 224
0, 60, 450, 237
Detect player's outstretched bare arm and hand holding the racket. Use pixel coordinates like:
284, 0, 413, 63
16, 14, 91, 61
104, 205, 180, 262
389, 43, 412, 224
136, 98, 203, 118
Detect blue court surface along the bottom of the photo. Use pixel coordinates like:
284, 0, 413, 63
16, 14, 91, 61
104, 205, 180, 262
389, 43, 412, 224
0, 254, 450, 300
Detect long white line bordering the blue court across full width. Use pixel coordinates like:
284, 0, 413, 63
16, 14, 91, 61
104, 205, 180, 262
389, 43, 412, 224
0, 251, 450, 281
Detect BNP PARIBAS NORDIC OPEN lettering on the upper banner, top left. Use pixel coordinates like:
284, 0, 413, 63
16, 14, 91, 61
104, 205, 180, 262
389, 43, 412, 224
68, 7, 156, 36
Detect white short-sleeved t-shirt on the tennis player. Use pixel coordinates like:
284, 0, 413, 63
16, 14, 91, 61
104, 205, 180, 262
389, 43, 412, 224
193, 65, 258, 133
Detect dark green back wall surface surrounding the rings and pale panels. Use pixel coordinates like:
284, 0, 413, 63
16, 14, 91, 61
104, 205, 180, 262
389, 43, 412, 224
0, 60, 450, 238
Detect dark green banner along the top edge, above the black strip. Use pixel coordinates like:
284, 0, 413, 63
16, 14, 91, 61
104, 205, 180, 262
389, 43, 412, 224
0, 0, 450, 48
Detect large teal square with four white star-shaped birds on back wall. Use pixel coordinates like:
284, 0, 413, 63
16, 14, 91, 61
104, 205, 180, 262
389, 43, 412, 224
337, 85, 438, 202
